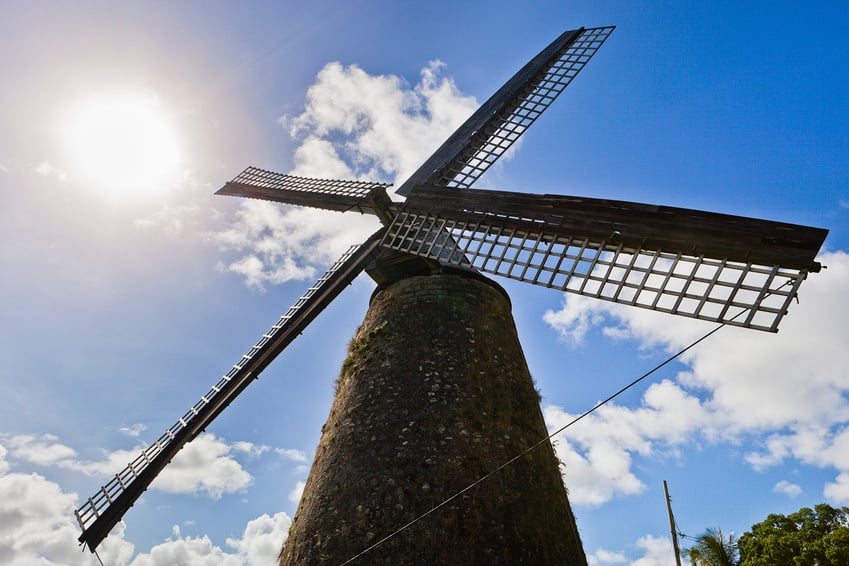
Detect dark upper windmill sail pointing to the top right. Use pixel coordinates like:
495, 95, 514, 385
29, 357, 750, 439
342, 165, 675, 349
397, 26, 614, 196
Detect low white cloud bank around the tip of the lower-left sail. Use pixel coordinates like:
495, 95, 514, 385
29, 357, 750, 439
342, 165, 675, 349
0, 435, 302, 566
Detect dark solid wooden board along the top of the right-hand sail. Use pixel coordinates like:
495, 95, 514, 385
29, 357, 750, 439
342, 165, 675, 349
405, 185, 828, 271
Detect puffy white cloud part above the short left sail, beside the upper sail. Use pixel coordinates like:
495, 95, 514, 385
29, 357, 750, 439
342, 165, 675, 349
288, 61, 478, 187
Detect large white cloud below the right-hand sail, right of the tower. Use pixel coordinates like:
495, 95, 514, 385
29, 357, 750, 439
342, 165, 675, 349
545, 252, 849, 504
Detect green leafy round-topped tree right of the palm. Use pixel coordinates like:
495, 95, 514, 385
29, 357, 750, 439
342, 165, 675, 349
738, 503, 849, 566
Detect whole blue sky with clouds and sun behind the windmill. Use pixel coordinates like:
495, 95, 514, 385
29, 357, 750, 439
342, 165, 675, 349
0, 1, 849, 566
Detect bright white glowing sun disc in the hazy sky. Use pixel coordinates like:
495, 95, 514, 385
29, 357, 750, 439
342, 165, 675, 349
63, 92, 180, 200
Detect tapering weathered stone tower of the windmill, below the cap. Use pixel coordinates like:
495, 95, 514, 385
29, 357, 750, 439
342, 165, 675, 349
280, 274, 586, 566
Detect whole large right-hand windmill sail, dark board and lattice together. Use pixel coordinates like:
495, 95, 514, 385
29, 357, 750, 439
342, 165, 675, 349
383, 187, 828, 332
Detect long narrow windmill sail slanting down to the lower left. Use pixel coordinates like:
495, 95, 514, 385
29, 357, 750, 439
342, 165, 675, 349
75, 231, 382, 551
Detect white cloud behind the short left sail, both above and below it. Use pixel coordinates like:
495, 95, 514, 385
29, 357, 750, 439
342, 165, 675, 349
211, 62, 477, 290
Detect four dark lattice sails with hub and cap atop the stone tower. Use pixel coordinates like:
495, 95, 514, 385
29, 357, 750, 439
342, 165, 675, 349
76, 27, 827, 555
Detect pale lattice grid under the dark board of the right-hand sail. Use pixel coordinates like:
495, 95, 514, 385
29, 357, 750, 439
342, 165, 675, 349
382, 211, 807, 332
